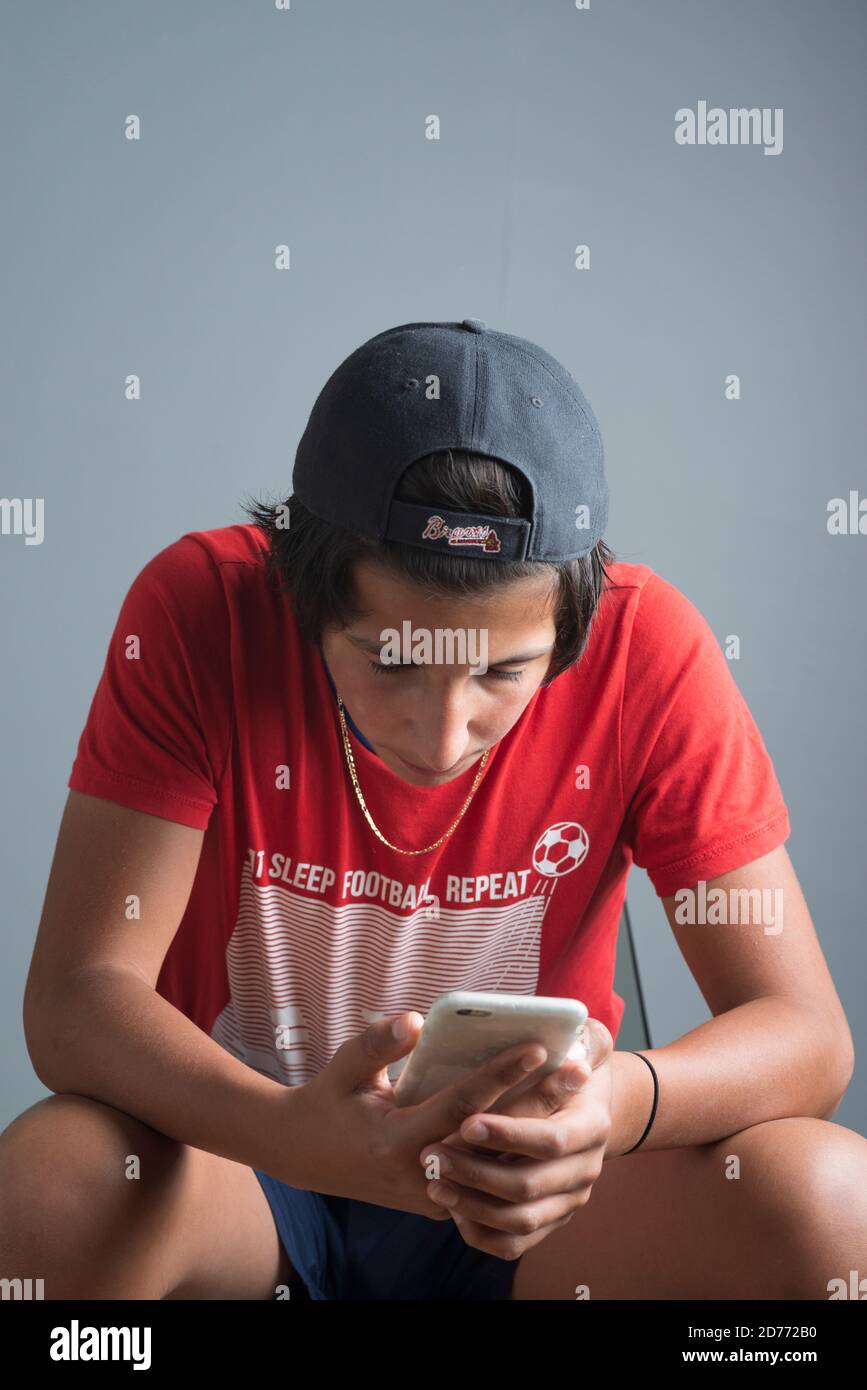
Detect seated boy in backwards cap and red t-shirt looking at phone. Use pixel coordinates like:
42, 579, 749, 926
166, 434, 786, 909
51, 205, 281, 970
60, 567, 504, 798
0, 320, 867, 1298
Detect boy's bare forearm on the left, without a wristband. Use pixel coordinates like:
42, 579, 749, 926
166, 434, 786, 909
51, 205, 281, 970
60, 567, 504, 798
28, 967, 300, 1182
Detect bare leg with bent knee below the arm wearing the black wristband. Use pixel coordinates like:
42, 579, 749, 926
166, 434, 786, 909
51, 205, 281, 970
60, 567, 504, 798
513, 1118, 867, 1300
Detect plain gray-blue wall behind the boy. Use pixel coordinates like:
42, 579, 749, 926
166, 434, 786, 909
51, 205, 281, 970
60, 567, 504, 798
0, 0, 867, 1130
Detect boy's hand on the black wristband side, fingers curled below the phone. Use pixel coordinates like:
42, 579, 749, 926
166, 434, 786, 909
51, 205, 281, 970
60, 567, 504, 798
420, 1019, 614, 1259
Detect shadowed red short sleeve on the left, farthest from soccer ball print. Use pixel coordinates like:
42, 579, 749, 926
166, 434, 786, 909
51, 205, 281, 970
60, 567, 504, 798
68, 537, 229, 830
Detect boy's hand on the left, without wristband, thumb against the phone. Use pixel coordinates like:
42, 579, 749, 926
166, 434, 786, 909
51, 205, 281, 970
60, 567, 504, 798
274, 1012, 547, 1220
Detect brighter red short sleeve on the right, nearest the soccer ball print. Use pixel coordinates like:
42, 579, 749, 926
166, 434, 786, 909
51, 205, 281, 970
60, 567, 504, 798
621, 574, 791, 898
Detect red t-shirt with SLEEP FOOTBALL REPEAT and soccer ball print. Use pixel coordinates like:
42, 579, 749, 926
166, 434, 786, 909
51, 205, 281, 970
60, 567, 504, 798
68, 525, 789, 1084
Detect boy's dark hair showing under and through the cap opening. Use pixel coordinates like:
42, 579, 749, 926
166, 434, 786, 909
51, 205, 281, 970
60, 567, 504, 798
242, 449, 616, 685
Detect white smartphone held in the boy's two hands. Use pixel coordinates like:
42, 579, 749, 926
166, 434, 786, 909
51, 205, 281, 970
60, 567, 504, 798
395, 990, 588, 1111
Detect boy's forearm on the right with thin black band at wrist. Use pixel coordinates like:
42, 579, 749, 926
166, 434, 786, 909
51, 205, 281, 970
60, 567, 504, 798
606, 998, 848, 1158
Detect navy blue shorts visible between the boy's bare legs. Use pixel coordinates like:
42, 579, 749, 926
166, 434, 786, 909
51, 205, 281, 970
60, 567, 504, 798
253, 1168, 520, 1300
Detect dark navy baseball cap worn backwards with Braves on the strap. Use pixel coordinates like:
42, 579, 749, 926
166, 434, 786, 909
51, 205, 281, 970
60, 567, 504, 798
292, 318, 609, 563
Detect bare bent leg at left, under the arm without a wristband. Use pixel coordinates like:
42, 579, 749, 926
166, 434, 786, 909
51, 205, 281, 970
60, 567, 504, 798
0, 1094, 296, 1298
